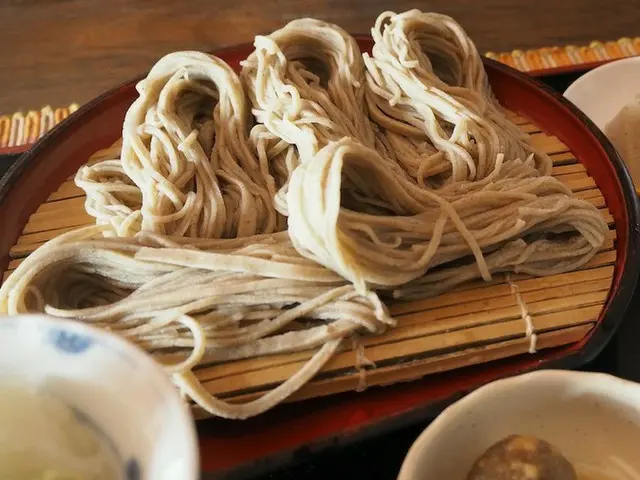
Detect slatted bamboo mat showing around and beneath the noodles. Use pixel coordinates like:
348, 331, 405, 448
4, 110, 616, 414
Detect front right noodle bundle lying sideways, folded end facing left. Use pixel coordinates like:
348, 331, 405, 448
287, 139, 606, 296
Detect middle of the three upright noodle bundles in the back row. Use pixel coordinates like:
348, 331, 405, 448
241, 18, 398, 215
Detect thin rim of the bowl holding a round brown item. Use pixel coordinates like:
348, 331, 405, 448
397, 369, 640, 480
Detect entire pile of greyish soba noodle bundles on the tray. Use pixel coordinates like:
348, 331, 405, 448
0, 10, 607, 418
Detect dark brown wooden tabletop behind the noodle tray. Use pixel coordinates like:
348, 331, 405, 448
0, 0, 640, 113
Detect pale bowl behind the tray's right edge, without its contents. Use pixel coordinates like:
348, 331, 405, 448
564, 57, 640, 132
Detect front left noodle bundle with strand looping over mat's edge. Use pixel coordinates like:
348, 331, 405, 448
0, 225, 393, 419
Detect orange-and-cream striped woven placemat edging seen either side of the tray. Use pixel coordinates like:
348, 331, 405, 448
0, 37, 640, 149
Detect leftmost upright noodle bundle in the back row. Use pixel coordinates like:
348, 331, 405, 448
76, 52, 283, 238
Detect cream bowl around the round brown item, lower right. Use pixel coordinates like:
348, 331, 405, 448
398, 370, 640, 480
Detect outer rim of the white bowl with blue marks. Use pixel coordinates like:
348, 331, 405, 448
0, 314, 199, 480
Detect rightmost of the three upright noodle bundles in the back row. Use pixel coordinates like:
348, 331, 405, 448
364, 10, 552, 185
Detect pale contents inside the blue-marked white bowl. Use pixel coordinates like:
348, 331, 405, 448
0, 385, 123, 480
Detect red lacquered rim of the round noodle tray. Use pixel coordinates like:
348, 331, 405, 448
0, 36, 640, 476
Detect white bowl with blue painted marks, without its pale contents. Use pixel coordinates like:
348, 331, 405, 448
0, 315, 199, 480
